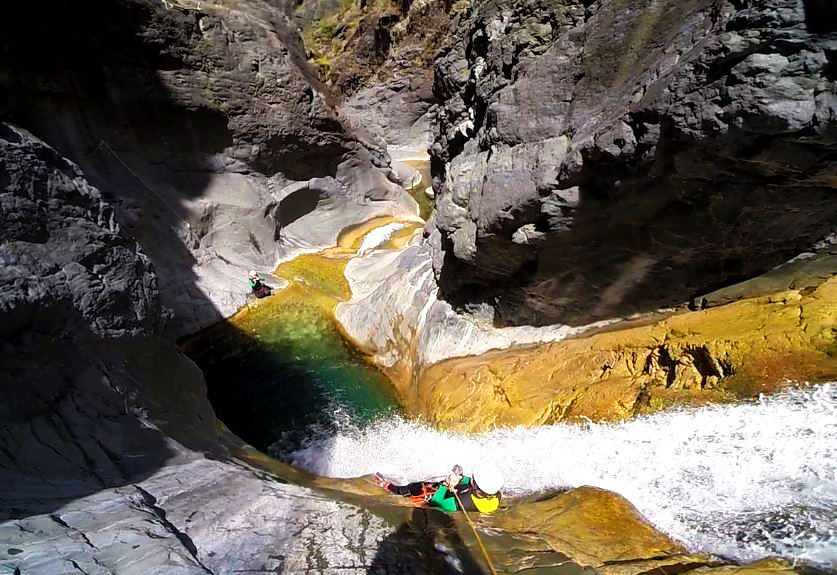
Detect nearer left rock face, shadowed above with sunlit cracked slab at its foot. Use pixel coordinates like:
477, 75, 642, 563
0, 124, 425, 574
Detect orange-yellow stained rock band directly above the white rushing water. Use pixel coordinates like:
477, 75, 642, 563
412, 278, 837, 431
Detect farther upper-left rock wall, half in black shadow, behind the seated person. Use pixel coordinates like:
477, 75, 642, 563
0, 0, 414, 335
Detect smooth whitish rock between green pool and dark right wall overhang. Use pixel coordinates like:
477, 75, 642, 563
335, 236, 612, 388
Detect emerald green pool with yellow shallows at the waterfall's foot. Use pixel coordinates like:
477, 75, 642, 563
184, 276, 399, 459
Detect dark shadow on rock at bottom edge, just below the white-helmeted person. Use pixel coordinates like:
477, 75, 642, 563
367, 509, 487, 575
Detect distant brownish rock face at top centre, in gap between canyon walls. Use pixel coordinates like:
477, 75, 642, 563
308, 0, 464, 155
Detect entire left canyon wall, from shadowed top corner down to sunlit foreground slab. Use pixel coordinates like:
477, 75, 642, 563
0, 0, 423, 574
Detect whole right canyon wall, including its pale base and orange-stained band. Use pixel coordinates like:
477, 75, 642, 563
337, 0, 837, 427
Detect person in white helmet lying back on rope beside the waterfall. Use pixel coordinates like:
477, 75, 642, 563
375, 463, 503, 513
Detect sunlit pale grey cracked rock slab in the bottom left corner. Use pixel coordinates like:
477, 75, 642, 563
0, 459, 402, 575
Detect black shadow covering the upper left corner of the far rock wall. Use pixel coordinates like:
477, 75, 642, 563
0, 0, 232, 332
